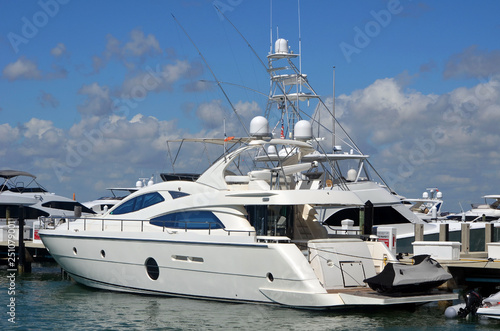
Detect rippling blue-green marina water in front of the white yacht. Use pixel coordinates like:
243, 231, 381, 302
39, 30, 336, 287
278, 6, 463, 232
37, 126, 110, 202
0, 263, 500, 330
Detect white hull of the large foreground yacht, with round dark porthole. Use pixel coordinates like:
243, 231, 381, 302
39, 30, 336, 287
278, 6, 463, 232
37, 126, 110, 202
41, 231, 456, 309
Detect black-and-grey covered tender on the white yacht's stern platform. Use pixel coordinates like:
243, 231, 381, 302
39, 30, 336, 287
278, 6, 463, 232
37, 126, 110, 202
364, 255, 452, 293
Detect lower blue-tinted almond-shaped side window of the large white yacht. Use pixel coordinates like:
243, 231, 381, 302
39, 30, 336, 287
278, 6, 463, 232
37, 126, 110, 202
149, 210, 224, 230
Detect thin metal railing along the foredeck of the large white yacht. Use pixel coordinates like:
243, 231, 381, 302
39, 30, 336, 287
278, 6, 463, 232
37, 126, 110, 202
38, 216, 255, 236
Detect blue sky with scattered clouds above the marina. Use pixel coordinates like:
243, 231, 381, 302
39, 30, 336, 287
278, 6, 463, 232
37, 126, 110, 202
0, 0, 500, 210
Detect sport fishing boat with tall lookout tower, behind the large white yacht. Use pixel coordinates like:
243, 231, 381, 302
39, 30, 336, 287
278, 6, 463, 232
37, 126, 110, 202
263, 38, 424, 233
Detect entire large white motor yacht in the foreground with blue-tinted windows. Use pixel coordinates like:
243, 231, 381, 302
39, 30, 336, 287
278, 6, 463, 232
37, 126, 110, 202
40, 122, 457, 309
